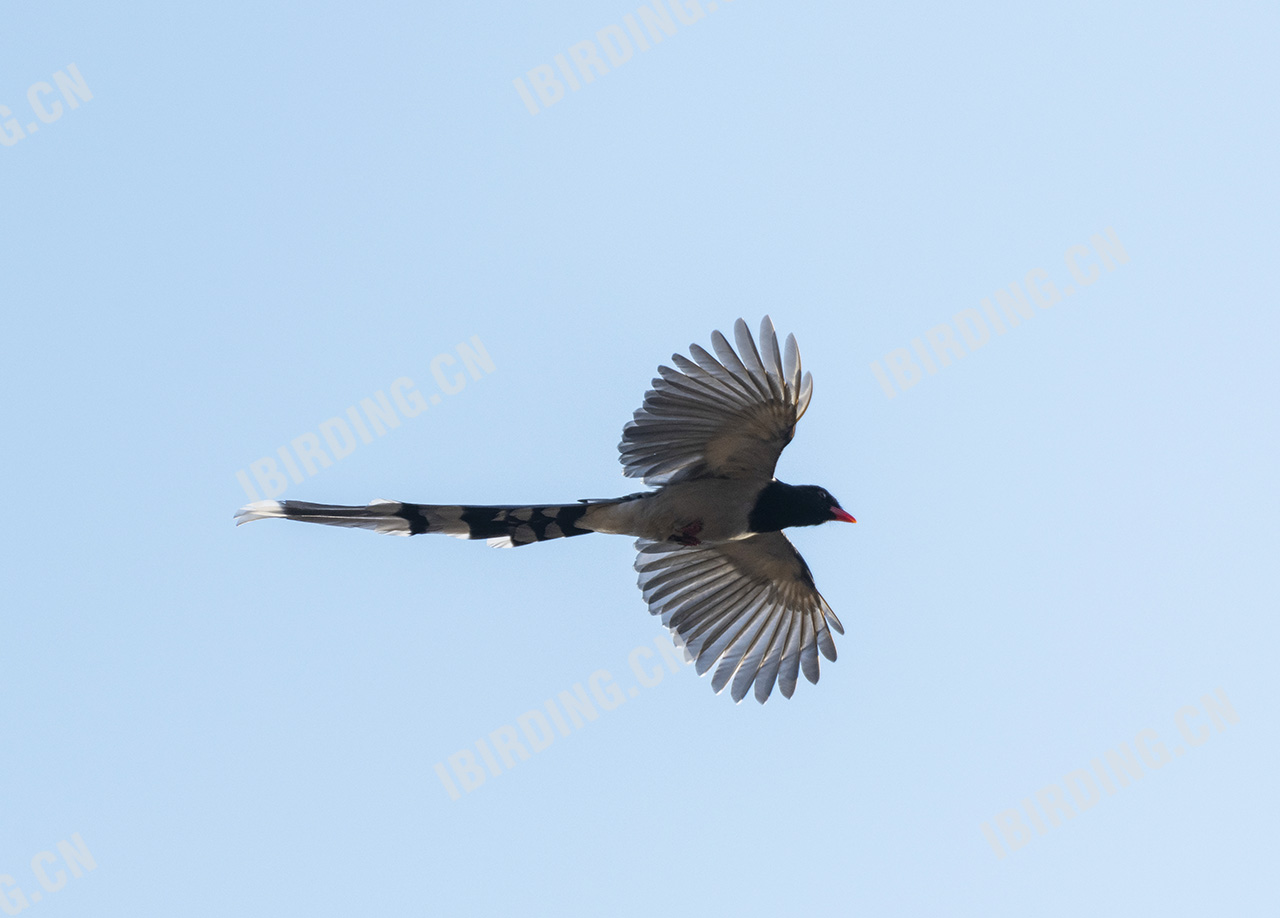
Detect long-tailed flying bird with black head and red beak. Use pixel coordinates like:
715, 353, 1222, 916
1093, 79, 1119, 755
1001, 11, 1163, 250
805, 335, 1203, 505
236, 316, 856, 704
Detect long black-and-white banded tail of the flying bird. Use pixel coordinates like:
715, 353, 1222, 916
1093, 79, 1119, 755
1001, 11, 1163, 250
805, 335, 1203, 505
236, 501, 604, 547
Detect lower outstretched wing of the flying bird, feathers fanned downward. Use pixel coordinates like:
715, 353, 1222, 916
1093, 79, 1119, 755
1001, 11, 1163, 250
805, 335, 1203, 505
636, 533, 845, 704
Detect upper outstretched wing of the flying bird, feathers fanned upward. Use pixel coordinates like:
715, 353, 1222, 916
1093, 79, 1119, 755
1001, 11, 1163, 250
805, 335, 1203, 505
618, 316, 813, 485
